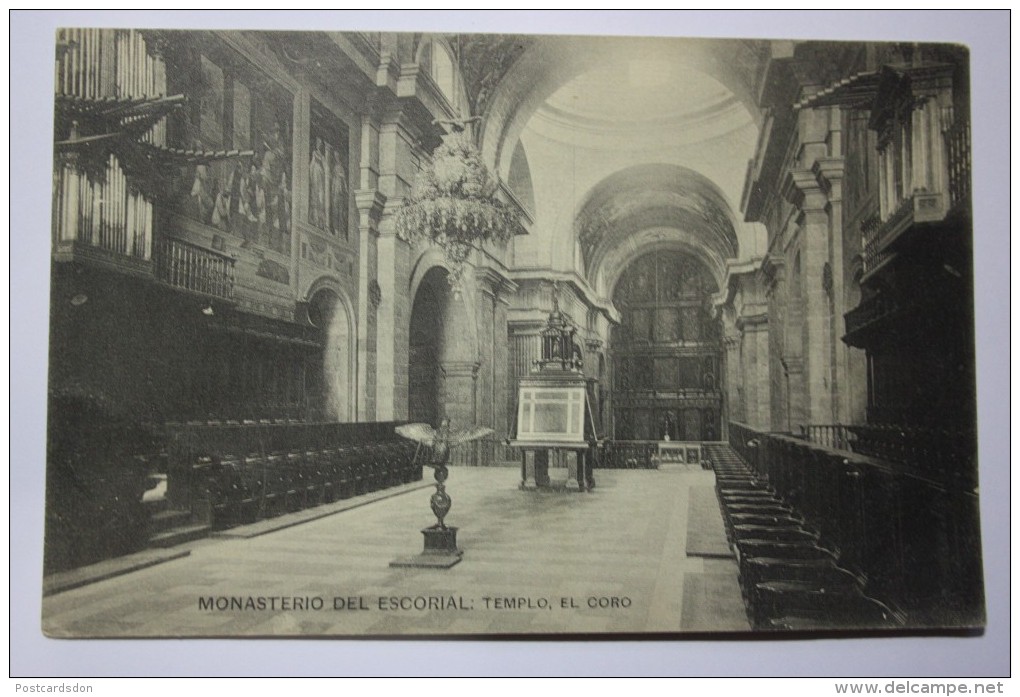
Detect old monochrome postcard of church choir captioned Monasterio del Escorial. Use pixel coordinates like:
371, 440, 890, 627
43, 24, 984, 636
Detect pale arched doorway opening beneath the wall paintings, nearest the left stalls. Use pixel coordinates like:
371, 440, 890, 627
308, 288, 357, 422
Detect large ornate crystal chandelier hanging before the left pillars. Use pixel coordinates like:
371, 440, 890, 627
397, 116, 523, 292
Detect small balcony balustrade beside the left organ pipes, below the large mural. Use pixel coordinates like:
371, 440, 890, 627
155, 237, 237, 300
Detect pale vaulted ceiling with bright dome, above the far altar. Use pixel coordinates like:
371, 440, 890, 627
451, 36, 770, 295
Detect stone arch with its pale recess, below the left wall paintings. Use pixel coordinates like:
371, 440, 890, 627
306, 277, 358, 422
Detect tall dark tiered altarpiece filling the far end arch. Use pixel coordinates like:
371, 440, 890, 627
610, 250, 722, 441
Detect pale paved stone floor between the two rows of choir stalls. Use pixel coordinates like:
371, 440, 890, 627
43, 467, 749, 637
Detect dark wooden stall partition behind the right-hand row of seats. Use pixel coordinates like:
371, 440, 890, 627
729, 422, 983, 626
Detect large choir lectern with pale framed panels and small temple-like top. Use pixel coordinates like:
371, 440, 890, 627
508, 288, 599, 491
